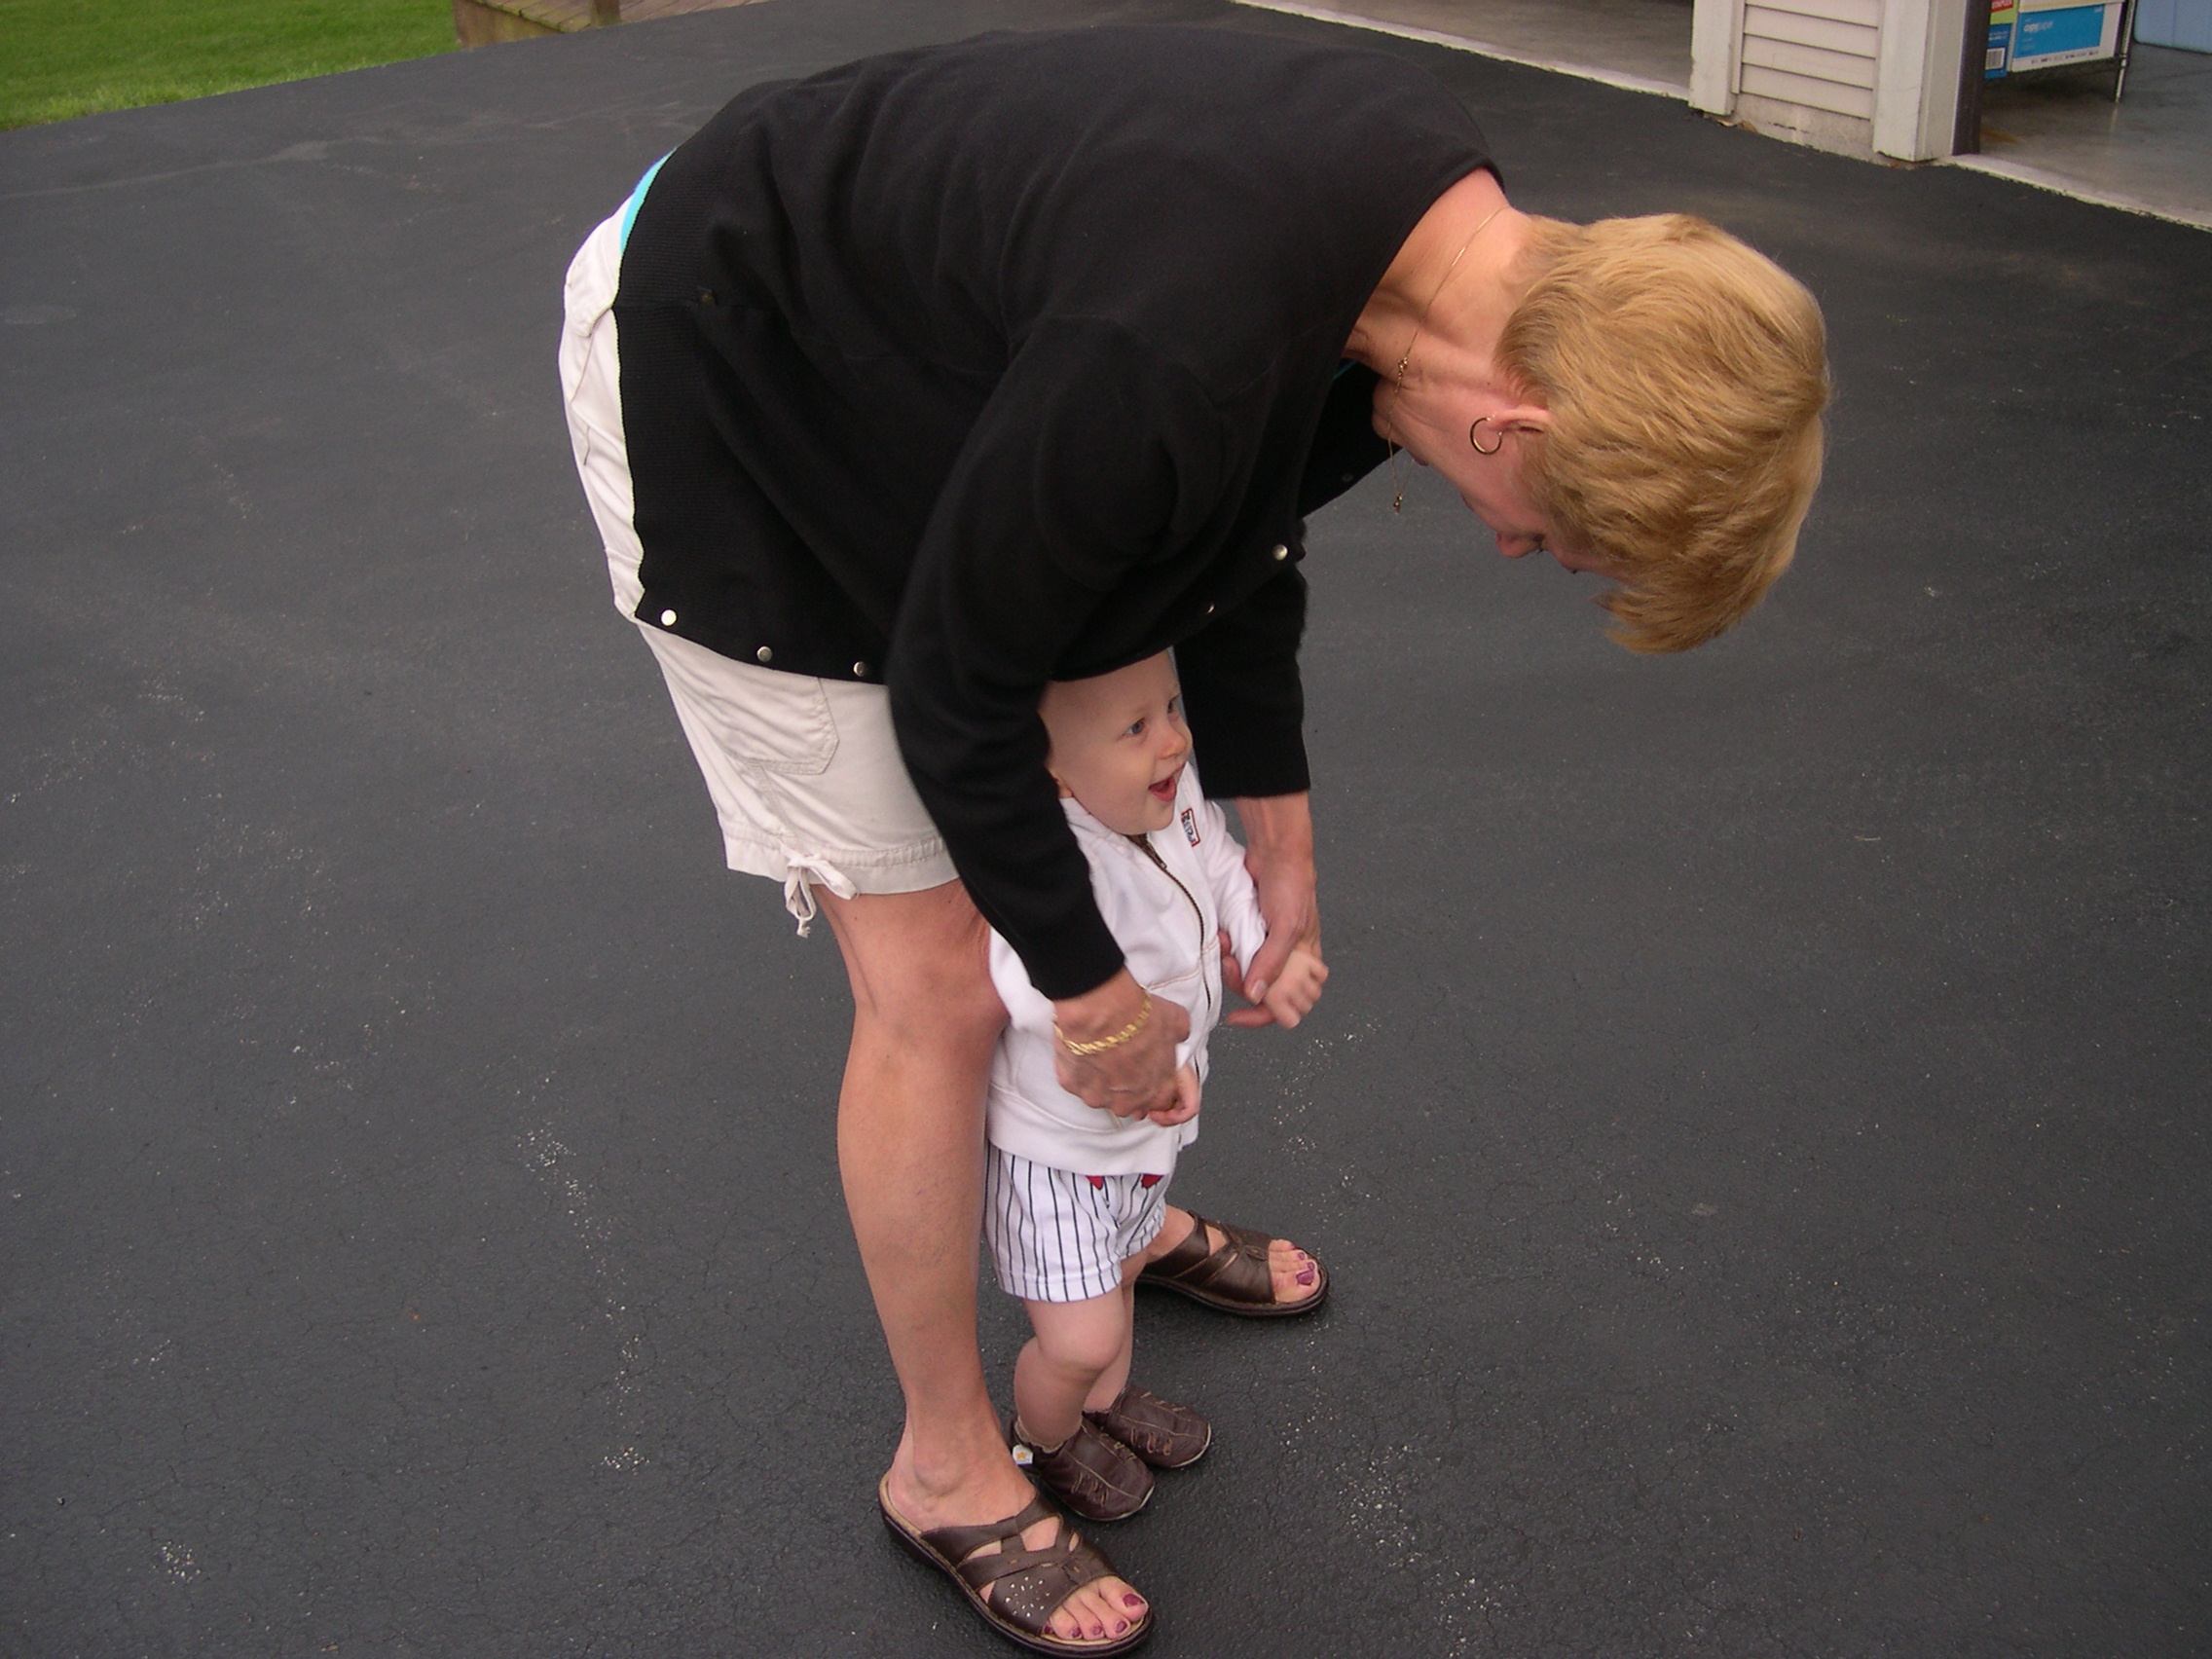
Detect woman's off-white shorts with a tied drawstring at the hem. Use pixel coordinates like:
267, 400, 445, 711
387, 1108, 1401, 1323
560, 212, 956, 934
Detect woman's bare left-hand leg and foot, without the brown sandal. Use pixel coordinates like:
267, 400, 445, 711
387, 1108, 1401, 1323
816, 883, 1144, 1640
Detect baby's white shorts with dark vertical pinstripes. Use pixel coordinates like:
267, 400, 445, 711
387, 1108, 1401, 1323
982, 1146, 1168, 1303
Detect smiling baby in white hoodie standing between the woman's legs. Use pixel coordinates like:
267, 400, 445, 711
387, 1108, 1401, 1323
984, 655, 1329, 1520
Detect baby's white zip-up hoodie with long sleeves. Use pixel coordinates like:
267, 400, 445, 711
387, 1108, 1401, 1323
989, 765, 1268, 1174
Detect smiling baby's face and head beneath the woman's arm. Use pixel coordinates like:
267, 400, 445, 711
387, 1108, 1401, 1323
1040, 652, 1190, 836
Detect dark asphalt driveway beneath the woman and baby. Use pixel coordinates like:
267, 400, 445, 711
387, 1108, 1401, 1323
0, 0, 2212, 1659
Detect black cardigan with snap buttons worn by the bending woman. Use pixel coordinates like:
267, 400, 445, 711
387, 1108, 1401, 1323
615, 29, 1489, 998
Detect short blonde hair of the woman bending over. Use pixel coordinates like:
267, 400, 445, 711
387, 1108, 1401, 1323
1499, 212, 1827, 650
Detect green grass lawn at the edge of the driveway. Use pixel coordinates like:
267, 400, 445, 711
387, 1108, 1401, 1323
0, 0, 454, 129
